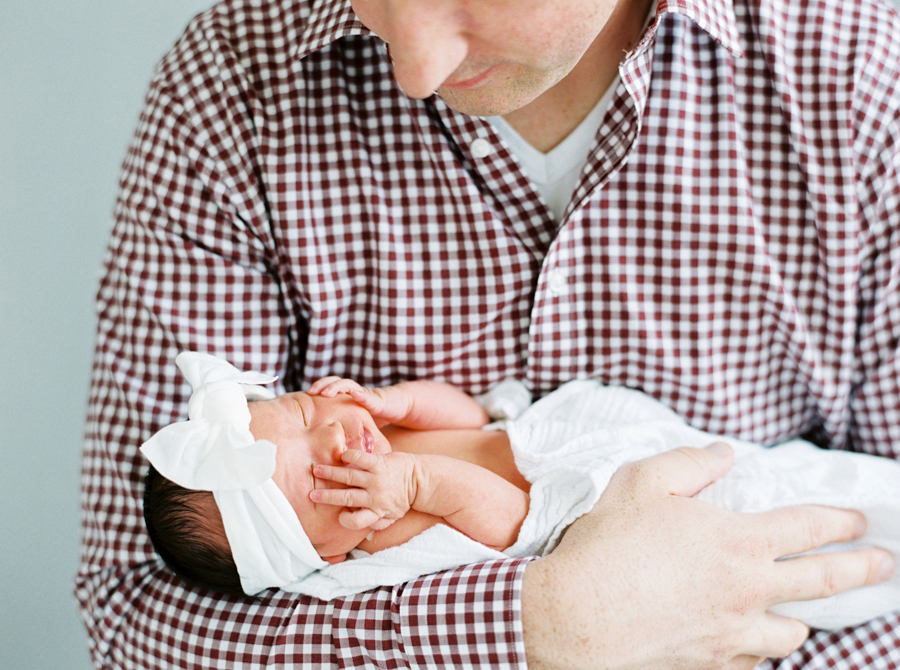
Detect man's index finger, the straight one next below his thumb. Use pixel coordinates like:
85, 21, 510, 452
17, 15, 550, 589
757, 505, 866, 558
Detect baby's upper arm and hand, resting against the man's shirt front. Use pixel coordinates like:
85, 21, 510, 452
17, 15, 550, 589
308, 377, 490, 430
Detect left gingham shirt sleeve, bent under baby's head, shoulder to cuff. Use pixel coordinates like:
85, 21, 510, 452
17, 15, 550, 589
75, 38, 528, 670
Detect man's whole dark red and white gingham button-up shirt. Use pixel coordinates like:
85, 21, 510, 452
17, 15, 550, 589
76, 0, 900, 669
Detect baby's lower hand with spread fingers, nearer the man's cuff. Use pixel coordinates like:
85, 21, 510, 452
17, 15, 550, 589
309, 449, 417, 530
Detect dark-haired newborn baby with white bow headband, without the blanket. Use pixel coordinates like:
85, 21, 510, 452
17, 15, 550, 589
142, 353, 529, 593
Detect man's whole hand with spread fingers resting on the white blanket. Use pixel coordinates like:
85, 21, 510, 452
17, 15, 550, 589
522, 445, 893, 670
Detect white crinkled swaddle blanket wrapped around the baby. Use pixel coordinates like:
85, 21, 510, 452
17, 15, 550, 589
297, 381, 900, 629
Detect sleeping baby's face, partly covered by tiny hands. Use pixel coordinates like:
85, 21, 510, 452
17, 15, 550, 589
248, 392, 391, 563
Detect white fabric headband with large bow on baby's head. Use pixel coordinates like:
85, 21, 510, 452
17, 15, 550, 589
141, 352, 328, 594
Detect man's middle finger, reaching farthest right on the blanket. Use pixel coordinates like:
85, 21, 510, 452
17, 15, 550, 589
772, 549, 894, 605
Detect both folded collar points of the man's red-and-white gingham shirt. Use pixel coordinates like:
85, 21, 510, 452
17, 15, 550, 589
293, 0, 744, 66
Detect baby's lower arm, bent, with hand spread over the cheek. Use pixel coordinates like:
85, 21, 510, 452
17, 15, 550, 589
310, 450, 529, 551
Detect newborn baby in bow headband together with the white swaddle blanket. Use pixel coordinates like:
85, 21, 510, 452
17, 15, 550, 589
143, 354, 900, 628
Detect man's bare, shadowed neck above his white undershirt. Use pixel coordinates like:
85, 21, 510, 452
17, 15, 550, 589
503, 0, 652, 153
